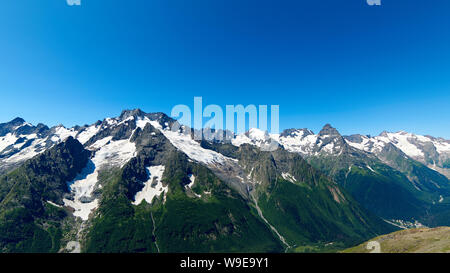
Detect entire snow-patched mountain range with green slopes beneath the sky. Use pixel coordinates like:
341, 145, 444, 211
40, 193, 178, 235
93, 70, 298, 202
0, 109, 450, 253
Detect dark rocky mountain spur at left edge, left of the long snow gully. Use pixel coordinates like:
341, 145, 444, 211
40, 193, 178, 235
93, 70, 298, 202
0, 137, 90, 252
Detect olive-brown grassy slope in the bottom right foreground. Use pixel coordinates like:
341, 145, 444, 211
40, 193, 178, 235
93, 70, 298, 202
343, 227, 450, 253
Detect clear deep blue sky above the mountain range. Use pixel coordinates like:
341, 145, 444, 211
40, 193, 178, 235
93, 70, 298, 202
0, 0, 450, 136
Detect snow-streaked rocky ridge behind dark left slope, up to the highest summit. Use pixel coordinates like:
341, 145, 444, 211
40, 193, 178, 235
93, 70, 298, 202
0, 109, 166, 173
